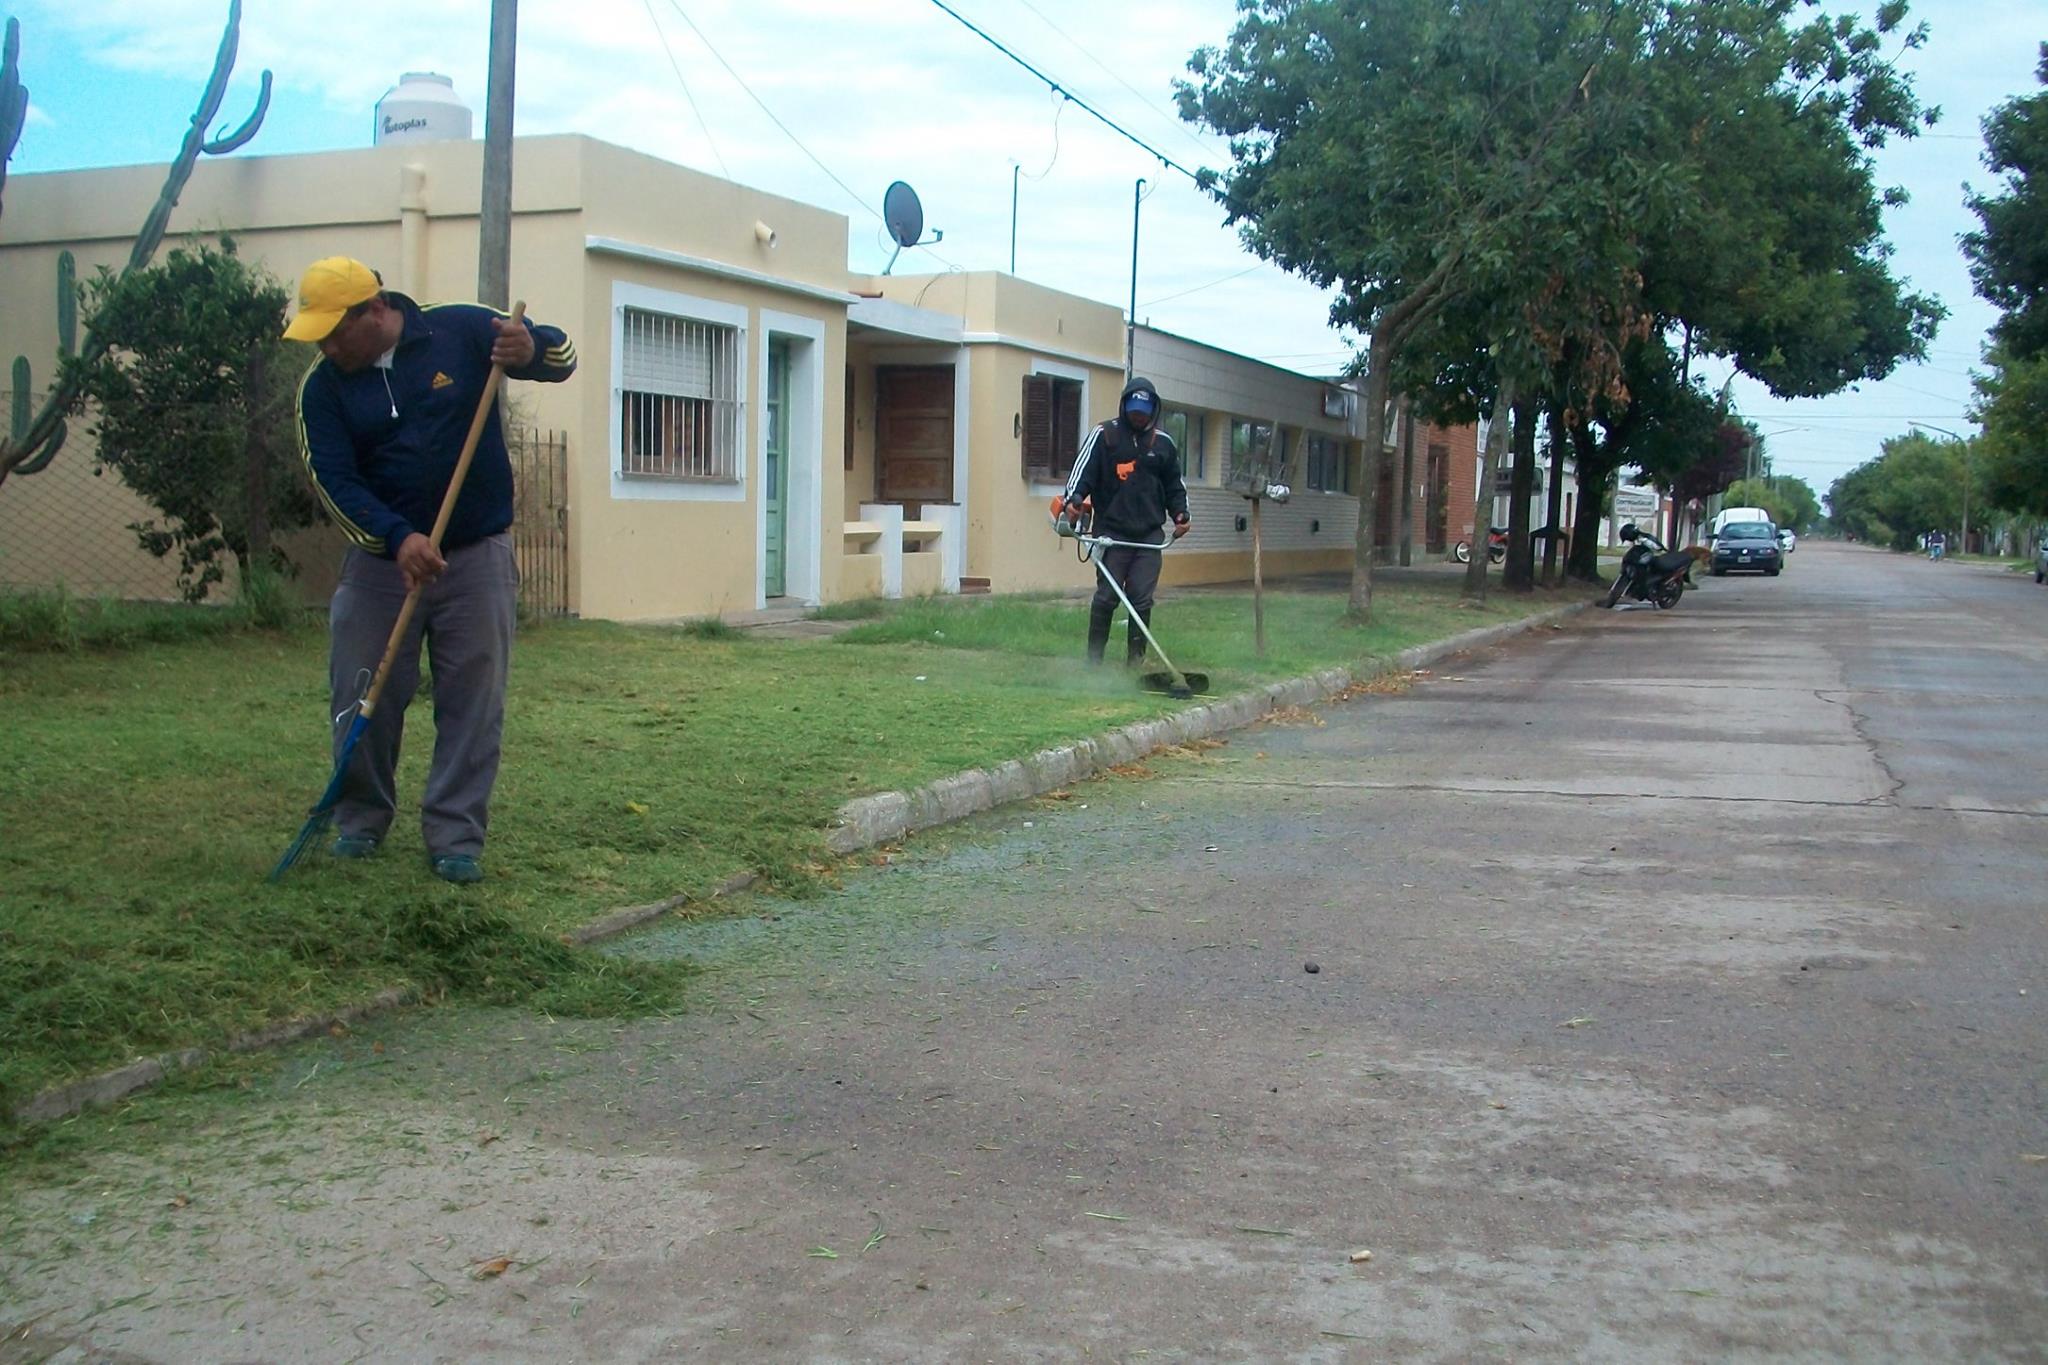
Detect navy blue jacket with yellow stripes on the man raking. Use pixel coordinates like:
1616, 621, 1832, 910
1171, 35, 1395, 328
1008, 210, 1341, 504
299, 291, 575, 559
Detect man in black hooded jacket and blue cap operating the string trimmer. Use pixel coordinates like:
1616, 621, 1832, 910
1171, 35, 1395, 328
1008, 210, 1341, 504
1055, 379, 1192, 667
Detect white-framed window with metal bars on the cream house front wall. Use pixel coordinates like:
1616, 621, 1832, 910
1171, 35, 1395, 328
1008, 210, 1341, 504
618, 307, 739, 483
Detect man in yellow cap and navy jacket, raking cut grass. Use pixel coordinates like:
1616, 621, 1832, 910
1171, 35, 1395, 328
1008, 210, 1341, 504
285, 256, 575, 882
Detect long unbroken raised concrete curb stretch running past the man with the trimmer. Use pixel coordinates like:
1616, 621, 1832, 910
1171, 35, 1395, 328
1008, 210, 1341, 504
825, 602, 1587, 855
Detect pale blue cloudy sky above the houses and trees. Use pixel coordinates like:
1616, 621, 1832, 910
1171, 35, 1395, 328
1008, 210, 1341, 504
0, 0, 2048, 493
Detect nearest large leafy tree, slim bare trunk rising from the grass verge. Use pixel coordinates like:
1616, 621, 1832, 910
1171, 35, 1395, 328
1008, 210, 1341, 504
1180, 0, 1653, 616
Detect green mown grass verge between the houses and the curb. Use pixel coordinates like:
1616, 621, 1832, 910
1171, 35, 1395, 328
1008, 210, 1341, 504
0, 579, 1579, 1113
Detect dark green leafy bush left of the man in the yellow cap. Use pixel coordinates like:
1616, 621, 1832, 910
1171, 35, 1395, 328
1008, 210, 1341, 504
66, 237, 319, 602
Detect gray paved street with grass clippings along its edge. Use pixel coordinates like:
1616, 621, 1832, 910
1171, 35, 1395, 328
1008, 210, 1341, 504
0, 542, 2048, 1361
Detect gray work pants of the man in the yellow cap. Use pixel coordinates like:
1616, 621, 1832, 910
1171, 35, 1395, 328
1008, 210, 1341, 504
328, 534, 518, 857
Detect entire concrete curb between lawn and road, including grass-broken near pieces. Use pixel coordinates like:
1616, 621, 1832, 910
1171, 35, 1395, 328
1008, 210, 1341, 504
12, 602, 1587, 1124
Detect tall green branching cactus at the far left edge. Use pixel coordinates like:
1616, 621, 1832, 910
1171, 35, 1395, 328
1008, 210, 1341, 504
0, 0, 270, 483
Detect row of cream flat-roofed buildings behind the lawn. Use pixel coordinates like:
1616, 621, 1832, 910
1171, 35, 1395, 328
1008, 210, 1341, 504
0, 135, 1392, 620
